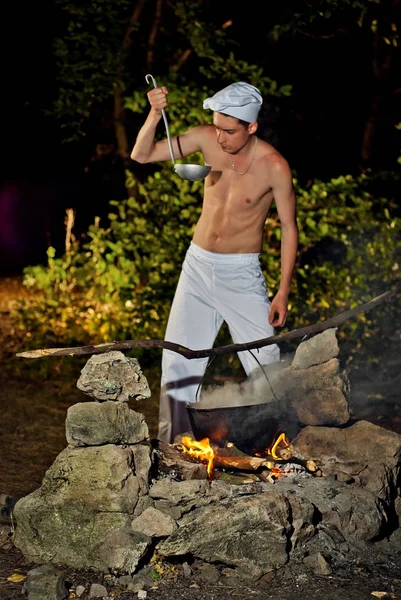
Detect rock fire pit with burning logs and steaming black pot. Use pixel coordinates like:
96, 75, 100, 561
13, 342, 401, 581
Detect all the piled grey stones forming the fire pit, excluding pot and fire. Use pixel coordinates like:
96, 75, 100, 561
11, 344, 401, 584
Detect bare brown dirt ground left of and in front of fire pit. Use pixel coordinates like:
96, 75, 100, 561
0, 277, 401, 600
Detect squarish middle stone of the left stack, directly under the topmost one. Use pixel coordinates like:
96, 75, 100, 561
65, 401, 149, 446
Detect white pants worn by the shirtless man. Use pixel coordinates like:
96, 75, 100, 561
158, 242, 280, 443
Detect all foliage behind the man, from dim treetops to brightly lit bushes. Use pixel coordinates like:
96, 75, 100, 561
13, 0, 401, 384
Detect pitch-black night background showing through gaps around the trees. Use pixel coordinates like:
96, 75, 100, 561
0, 2, 400, 275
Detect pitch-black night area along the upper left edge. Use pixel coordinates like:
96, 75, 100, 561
0, 2, 87, 275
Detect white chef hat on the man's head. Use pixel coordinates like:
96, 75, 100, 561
203, 81, 263, 123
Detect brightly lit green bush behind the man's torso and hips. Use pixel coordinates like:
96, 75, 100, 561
16, 169, 401, 360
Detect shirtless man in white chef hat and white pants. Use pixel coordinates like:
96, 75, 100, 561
131, 82, 298, 442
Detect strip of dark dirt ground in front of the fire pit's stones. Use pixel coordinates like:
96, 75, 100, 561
0, 544, 401, 600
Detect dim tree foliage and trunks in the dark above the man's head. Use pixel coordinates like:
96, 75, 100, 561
52, 0, 400, 175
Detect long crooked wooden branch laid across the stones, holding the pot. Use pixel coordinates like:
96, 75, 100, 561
16, 291, 395, 360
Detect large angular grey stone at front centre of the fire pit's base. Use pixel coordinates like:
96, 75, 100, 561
158, 492, 291, 577
